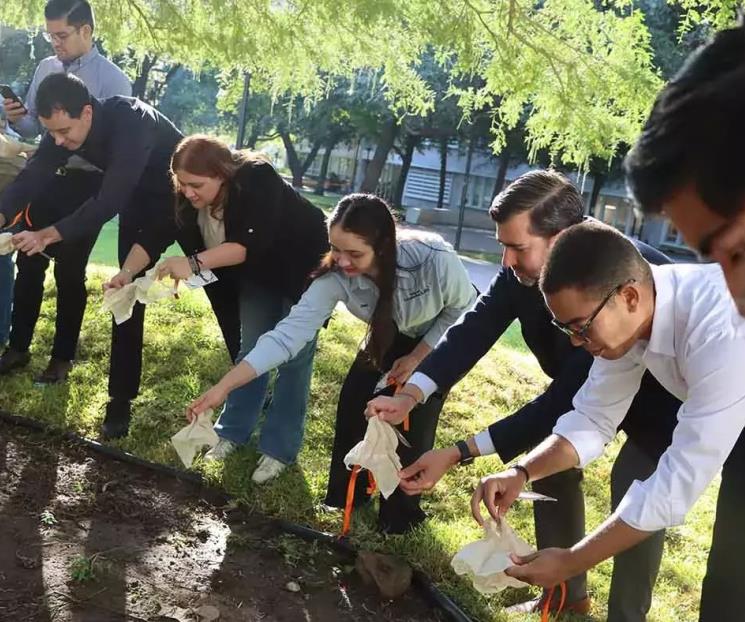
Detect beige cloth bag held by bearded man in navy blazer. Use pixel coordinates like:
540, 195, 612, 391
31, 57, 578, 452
344, 417, 401, 499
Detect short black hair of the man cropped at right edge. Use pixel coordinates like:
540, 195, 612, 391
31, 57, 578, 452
624, 26, 745, 217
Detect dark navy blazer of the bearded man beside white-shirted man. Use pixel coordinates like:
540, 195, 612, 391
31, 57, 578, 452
417, 241, 680, 462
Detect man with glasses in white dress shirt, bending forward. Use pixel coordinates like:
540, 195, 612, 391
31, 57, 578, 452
472, 222, 745, 622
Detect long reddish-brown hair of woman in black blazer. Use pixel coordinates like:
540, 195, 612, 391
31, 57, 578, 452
171, 134, 271, 221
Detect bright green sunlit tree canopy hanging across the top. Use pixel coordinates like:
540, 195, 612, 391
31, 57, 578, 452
0, 0, 734, 166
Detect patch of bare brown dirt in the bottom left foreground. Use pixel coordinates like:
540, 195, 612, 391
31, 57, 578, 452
0, 422, 441, 622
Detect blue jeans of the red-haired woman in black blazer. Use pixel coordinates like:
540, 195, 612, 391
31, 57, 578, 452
215, 283, 317, 464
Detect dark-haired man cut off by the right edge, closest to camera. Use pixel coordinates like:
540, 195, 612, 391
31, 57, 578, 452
625, 22, 745, 620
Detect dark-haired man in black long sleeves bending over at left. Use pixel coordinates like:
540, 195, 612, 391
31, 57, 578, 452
0, 74, 182, 438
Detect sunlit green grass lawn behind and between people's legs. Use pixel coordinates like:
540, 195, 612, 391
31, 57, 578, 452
0, 267, 716, 622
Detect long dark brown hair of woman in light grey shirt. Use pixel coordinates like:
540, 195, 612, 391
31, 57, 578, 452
312, 193, 396, 371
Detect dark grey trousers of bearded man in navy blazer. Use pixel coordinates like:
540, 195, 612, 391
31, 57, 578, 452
533, 440, 665, 622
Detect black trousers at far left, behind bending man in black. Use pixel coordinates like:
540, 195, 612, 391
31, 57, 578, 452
10, 171, 102, 361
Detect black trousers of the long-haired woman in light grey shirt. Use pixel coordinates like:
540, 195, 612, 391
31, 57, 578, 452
325, 334, 444, 533
